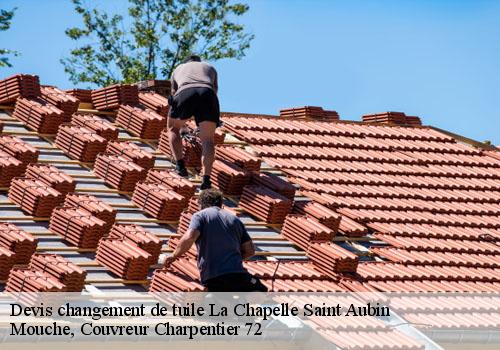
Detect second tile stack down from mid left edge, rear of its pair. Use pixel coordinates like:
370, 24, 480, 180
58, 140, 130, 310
26, 163, 76, 196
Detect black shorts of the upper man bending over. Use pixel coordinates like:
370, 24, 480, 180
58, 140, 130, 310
169, 87, 220, 125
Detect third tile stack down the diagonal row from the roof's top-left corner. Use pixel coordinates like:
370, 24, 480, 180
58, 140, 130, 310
55, 125, 107, 163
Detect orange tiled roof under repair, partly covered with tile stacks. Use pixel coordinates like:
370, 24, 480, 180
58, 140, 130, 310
0, 74, 500, 348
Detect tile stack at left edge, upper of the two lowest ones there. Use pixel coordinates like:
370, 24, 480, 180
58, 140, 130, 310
0, 222, 38, 265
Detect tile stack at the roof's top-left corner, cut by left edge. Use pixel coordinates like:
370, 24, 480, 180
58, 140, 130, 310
0, 74, 40, 104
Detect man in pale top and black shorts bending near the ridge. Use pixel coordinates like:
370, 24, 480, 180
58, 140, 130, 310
167, 56, 220, 190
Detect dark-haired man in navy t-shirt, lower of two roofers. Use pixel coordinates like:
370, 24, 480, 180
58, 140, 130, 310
165, 189, 267, 292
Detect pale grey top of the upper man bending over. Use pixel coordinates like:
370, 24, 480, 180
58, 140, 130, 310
172, 62, 218, 95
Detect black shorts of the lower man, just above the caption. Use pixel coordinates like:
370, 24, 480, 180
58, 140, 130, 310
205, 272, 267, 292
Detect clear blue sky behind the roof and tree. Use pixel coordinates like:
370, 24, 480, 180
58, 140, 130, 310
0, 0, 500, 144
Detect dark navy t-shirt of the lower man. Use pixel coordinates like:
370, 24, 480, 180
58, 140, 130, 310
189, 207, 250, 283
